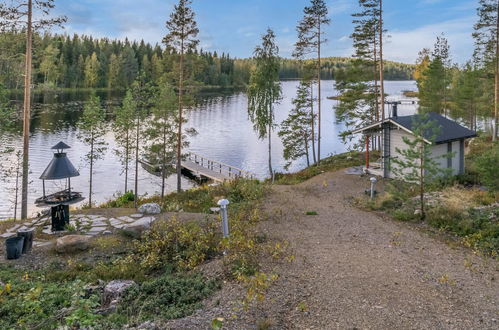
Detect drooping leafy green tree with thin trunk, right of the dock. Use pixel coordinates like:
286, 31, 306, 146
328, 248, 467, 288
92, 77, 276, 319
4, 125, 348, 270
247, 28, 282, 177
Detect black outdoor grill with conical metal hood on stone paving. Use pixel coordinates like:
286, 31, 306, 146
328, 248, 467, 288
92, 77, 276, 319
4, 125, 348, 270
35, 142, 83, 231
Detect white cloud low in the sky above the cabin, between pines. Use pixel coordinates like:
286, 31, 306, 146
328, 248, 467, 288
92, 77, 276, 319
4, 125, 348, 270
384, 17, 475, 63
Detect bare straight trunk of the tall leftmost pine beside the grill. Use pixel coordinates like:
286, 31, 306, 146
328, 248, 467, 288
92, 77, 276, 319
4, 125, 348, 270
21, 0, 33, 220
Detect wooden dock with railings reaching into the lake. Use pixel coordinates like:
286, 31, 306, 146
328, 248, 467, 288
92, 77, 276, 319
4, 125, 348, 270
140, 153, 256, 183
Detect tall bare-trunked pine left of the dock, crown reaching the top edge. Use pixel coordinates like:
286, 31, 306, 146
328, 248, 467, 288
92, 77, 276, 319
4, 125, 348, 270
163, 0, 199, 192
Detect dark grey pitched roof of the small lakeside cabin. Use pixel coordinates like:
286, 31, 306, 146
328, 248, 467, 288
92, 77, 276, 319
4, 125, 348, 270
390, 112, 476, 144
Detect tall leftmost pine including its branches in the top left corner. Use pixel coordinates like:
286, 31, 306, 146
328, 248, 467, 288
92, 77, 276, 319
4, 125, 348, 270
0, 0, 66, 219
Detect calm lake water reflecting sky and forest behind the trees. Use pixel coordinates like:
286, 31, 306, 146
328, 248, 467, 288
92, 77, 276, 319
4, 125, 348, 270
0, 81, 417, 219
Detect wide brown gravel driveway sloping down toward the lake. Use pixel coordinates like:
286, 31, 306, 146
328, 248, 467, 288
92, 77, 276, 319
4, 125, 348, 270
168, 171, 499, 329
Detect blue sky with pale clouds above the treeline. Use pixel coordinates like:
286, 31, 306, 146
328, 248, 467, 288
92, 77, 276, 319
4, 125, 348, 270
55, 0, 478, 64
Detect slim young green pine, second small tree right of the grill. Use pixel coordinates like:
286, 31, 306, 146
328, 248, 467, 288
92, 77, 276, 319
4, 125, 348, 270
114, 90, 137, 193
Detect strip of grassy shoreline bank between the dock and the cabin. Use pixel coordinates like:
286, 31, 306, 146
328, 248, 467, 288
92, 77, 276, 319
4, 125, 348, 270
275, 151, 368, 185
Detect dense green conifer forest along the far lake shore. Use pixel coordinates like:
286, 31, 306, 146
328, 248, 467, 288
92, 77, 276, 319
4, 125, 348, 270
0, 33, 413, 89
